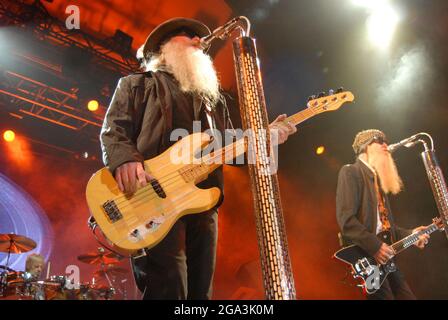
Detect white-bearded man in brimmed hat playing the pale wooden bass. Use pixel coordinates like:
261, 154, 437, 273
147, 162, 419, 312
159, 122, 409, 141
101, 18, 296, 299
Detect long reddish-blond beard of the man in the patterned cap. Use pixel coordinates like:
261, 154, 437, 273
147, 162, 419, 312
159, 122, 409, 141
369, 153, 403, 194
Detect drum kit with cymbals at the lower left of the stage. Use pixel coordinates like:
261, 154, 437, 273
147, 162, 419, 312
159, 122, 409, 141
0, 234, 128, 300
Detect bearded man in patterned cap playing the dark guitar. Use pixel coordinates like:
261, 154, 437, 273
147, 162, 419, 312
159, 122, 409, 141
336, 129, 429, 300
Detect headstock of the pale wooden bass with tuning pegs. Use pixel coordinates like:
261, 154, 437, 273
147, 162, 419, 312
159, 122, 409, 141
307, 88, 355, 114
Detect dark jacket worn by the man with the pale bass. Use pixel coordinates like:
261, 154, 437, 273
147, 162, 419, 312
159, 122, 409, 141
100, 72, 233, 196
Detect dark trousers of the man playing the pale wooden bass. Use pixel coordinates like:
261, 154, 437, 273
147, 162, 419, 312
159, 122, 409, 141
131, 209, 218, 300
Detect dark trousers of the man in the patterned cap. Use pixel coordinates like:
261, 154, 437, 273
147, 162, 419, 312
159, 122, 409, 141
367, 270, 417, 300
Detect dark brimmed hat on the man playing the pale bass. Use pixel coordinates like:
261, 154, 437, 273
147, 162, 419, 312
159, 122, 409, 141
143, 18, 211, 57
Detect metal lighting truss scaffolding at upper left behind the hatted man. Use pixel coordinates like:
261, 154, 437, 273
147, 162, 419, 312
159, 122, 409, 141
0, 0, 139, 145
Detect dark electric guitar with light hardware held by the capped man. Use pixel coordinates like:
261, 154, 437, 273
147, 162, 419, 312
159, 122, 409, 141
333, 218, 443, 294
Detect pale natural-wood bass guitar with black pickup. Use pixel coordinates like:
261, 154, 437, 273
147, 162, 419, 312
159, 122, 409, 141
86, 90, 354, 255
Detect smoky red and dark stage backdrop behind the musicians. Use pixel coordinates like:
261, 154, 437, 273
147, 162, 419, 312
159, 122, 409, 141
0, 0, 448, 299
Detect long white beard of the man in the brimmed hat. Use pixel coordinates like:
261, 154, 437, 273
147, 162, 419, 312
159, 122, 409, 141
161, 42, 221, 105
